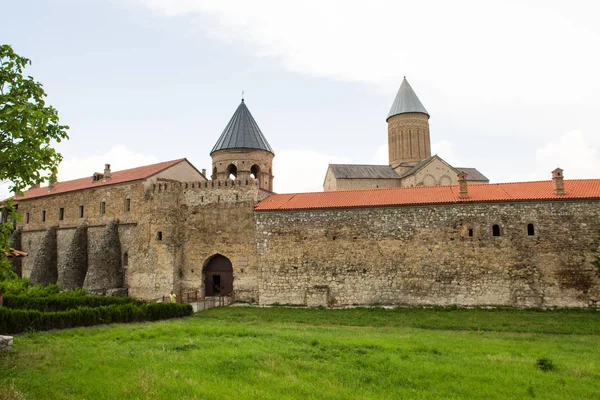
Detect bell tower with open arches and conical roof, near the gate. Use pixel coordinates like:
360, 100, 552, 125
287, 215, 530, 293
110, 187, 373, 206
210, 99, 275, 192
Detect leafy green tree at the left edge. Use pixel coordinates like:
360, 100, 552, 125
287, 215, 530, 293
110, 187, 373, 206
0, 44, 69, 280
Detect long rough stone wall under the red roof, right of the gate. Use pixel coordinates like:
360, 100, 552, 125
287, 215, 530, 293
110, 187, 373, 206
255, 201, 600, 307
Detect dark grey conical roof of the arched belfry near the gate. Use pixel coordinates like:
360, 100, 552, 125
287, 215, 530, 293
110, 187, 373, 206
210, 99, 275, 154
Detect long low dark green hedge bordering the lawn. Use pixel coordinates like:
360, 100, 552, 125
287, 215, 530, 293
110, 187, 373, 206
0, 304, 193, 334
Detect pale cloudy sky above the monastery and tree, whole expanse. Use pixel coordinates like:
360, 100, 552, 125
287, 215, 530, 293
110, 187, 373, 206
0, 0, 600, 197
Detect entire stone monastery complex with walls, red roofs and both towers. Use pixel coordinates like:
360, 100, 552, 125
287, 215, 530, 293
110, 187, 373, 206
9, 86, 600, 307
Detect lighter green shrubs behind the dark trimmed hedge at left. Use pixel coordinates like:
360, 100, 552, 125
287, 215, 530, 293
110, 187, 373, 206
4, 291, 144, 312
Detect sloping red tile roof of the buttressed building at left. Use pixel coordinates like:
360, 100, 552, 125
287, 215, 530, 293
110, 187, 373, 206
15, 158, 185, 201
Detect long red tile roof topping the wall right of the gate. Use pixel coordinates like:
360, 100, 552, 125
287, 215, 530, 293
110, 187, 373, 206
254, 179, 600, 211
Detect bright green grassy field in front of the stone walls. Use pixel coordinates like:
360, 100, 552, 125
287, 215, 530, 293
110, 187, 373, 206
0, 307, 600, 399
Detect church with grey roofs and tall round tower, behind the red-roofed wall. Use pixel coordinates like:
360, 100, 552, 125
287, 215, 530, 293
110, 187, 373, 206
323, 77, 489, 192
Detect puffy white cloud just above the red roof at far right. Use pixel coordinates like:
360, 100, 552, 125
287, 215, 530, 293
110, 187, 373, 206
508, 131, 600, 182
